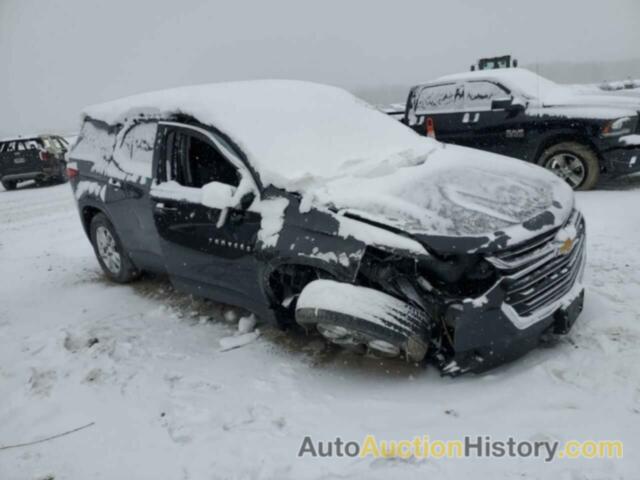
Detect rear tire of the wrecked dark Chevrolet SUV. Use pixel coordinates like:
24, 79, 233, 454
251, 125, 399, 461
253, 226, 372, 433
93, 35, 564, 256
90, 213, 140, 283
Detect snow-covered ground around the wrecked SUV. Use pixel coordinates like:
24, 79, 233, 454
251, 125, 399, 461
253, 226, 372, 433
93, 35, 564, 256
0, 177, 640, 480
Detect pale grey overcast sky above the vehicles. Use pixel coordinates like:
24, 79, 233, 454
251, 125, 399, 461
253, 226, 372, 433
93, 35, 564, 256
0, 0, 640, 136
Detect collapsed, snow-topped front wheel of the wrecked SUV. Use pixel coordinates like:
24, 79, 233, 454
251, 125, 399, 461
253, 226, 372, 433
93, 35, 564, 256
296, 280, 431, 362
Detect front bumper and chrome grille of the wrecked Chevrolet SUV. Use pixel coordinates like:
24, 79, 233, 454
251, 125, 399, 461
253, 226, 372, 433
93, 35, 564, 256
440, 210, 586, 374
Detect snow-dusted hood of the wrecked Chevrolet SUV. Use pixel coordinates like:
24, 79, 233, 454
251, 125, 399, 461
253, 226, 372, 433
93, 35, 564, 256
304, 145, 573, 253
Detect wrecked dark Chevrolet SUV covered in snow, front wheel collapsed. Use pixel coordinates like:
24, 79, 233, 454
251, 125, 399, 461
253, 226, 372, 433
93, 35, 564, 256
68, 81, 585, 374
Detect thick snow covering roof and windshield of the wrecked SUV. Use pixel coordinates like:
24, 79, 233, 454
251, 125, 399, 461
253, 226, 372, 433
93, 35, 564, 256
83, 80, 437, 188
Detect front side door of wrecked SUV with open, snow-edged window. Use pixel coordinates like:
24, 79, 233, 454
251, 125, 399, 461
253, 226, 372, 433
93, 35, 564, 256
151, 122, 261, 305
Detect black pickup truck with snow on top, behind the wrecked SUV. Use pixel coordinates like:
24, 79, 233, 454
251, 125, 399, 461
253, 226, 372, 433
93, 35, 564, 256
403, 68, 640, 190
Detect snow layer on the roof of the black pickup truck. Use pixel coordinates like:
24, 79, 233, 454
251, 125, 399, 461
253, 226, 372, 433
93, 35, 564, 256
429, 68, 564, 98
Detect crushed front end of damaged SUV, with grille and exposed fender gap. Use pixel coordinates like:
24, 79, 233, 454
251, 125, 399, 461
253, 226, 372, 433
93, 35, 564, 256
359, 209, 586, 375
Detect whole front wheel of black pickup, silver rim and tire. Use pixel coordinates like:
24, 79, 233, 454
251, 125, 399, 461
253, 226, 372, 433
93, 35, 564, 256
538, 142, 600, 190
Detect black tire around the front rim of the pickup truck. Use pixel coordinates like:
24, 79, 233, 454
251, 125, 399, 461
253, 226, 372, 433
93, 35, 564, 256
538, 142, 600, 190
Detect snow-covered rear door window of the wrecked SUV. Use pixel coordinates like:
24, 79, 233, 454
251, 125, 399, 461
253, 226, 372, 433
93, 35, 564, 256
113, 122, 158, 178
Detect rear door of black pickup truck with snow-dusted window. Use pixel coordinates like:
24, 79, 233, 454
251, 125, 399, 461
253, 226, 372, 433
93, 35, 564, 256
408, 83, 467, 144
